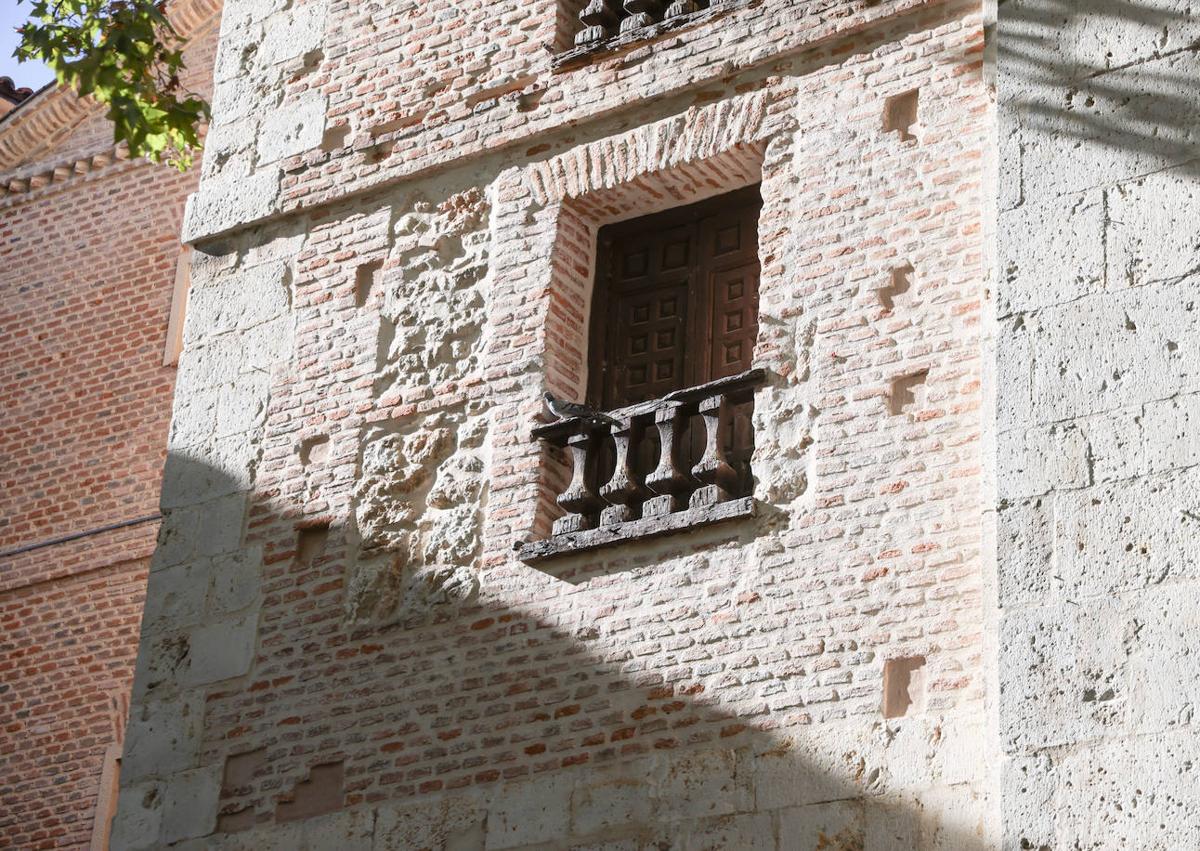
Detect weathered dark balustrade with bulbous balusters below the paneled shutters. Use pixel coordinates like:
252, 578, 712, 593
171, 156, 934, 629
521, 370, 764, 562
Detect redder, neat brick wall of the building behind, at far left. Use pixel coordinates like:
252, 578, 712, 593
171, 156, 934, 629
0, 6, 217, 849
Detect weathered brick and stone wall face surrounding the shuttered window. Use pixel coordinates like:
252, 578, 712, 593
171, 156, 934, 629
114, 1, 994, 850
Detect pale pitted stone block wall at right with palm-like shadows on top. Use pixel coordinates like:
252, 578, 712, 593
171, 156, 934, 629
996, 0, 1200, 849
